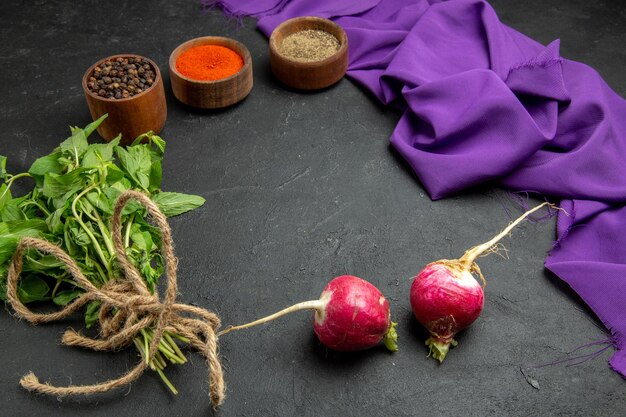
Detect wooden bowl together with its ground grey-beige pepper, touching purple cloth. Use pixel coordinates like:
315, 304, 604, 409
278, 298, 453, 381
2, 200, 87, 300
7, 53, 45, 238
269, 16, 348, 90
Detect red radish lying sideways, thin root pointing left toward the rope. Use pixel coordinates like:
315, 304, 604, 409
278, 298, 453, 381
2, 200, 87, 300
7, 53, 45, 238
218, 275, 398, 352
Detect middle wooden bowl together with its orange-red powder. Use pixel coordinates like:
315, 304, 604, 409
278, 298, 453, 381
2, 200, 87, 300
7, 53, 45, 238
169, 36, 252, 109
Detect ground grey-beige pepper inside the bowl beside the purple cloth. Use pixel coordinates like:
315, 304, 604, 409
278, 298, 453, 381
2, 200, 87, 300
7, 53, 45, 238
278, 29, 340, 62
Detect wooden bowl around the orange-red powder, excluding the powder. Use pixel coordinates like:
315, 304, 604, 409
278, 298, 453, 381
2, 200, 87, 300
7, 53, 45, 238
169, 36, 252, 109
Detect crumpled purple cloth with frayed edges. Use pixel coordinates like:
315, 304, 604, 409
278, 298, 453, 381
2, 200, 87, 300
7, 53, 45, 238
205, 0, 626, 377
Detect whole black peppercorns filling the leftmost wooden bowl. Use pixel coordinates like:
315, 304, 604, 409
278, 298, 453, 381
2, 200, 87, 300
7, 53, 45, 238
87, 56, 156, 99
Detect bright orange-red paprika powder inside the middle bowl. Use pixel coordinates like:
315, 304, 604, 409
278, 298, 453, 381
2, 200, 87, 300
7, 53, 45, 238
176, 45, 243, 81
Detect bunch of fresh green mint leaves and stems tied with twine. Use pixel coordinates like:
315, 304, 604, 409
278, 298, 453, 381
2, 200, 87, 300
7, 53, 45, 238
0, 115, 205, 393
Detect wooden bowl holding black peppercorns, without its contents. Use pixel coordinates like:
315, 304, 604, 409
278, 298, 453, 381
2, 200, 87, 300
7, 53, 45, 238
83, 54, 167, 145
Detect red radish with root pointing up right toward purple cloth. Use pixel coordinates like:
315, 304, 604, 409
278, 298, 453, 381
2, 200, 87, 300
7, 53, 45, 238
411, 203, 554, 362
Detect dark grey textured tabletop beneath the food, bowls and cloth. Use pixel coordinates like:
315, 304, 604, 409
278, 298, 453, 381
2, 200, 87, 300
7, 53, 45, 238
0, 0, 626, 416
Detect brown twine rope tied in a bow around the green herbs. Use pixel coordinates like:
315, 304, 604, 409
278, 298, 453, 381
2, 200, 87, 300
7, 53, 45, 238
7, 191, 225, 407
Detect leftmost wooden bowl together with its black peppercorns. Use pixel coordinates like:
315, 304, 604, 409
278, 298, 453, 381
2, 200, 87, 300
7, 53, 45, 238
83, 54, 167, 145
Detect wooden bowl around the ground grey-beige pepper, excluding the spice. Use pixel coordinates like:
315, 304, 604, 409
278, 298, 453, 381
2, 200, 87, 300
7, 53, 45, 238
270, 16, 348, 90
